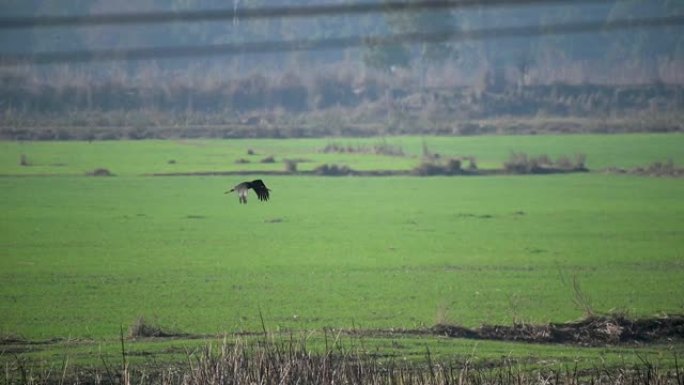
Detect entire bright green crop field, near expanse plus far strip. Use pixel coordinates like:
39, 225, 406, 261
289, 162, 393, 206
0, 135, 684, 372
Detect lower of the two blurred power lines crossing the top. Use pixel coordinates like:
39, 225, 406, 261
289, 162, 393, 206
0, 15, 684, 65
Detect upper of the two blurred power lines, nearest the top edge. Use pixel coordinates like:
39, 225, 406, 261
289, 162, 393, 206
0, 0, 611, 29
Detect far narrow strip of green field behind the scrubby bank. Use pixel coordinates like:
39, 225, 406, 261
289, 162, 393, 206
0, 134, 684, 176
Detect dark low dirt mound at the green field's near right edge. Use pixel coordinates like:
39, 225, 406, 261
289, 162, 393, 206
430, 315, 684, 346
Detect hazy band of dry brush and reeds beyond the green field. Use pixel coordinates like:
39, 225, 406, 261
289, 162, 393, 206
0, 67, 684, 140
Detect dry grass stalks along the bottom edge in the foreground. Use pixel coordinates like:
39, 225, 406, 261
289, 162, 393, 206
3, 328, 684, 385
